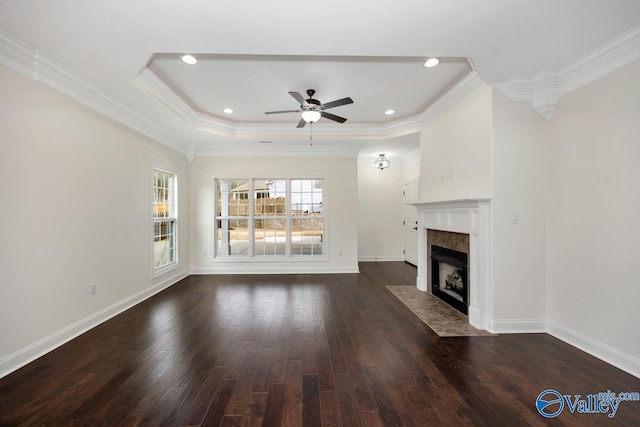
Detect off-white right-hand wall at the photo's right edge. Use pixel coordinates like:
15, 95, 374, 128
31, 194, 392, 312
547, 61, 640, 370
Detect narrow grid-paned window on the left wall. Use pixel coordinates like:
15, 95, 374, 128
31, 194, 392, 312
153, 169, 178, 269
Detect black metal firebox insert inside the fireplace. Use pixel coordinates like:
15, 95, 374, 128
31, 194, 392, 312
431, 245, 469, 315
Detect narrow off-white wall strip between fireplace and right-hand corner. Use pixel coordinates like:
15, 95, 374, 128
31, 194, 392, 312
491, 88, 548, 332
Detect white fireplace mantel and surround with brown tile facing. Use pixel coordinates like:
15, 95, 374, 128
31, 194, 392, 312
414, 199, 493, 332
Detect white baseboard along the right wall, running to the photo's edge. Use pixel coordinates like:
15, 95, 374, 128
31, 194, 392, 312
547, 321, 640, 378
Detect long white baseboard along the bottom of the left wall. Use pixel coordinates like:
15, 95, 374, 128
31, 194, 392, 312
0, 271, 189, 378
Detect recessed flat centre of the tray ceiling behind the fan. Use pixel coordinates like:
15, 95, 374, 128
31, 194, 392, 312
149, 54, 471, 127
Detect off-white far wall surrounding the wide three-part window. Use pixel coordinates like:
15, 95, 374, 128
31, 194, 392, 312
191, 157, 358, 274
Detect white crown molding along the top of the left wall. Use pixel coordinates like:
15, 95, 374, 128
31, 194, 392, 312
0, 30, 186, 153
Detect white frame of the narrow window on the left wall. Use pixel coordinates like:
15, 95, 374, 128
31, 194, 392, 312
151, 167, 179, 277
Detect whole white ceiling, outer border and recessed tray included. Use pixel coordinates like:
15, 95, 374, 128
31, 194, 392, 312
0, 0, 640, 162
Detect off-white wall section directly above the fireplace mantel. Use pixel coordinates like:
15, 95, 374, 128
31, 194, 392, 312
420, 85, 491, 202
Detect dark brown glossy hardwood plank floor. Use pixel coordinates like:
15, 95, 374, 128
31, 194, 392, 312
0, 262, 640, 427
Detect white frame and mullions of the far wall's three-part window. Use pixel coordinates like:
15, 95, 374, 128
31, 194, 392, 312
211, 175, 329, 262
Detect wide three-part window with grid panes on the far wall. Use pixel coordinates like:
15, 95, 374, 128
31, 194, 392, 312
215, 178, 325, 258
